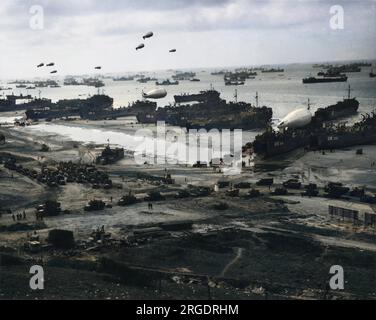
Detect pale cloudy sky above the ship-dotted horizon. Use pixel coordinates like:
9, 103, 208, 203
0, 0, 376, 78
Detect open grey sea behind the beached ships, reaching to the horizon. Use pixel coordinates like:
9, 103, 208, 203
0, 62, 376, 119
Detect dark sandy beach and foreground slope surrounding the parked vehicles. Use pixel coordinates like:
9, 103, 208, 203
0, 121, 376, 299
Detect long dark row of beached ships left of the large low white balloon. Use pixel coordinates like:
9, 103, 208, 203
6, 90, 273, 130
